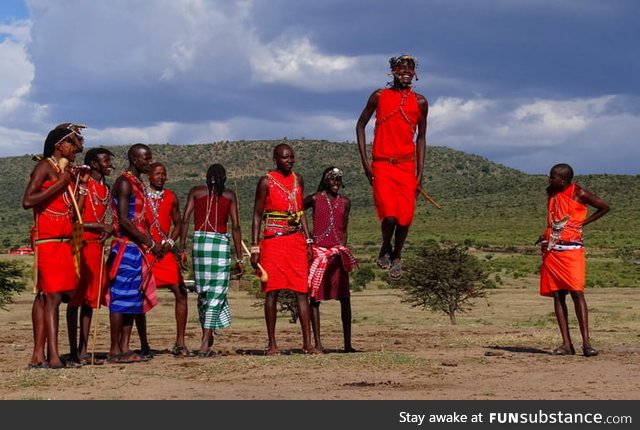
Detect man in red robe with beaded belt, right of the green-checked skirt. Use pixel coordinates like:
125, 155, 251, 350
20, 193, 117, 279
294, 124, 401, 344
250, 143, 318, 355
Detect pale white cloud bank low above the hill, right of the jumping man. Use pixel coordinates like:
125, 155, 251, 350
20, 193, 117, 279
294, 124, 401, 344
429, 95, 640, 173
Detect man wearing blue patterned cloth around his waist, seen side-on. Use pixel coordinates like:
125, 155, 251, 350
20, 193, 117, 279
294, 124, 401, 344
107, 143, 164, 363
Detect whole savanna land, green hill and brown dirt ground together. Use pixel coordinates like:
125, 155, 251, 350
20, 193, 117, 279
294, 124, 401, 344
0, 141, 640, 400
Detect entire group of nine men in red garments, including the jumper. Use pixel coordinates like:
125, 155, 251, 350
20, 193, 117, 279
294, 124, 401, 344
23, 55, 608, 368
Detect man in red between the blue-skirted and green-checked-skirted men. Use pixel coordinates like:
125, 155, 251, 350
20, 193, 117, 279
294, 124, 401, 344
135, 163, 189, 357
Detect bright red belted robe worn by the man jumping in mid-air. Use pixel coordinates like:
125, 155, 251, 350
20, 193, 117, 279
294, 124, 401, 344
371, 88, 421, 226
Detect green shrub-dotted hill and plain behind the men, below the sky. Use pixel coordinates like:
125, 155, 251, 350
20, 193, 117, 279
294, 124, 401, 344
0, 140, 640, 250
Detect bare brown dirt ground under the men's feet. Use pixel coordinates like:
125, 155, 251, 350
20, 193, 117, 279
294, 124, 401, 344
0, 279, 640, 400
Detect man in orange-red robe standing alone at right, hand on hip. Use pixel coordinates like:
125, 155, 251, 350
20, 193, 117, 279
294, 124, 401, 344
538, 163, 609, 357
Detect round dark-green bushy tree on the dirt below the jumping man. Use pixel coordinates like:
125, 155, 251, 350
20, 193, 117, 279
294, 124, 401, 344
394, 242, 491, 324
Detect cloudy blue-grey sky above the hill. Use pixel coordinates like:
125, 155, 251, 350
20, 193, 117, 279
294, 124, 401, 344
0, 0, 640, 175
